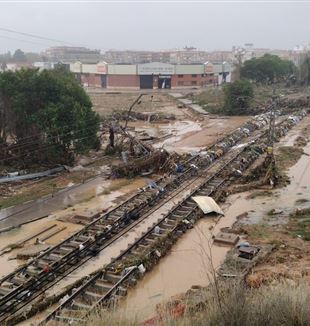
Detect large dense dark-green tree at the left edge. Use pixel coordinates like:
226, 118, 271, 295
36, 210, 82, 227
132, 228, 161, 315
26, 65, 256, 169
0, 69, 99, 166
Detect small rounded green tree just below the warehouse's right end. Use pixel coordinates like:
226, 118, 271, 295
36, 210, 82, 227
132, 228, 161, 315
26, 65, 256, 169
223, 79, 254, 115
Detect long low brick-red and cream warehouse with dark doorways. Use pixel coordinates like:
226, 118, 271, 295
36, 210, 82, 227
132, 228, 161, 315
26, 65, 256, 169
67, 61, 233, 89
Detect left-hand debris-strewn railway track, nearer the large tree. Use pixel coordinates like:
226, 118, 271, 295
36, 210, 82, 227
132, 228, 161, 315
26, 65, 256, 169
0, 111, 302, 322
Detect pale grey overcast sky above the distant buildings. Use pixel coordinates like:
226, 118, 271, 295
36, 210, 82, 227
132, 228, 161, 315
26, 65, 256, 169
0, 0, 310, 52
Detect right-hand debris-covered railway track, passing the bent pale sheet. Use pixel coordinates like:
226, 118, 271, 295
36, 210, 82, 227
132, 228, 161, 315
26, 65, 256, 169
39, 110, 306, 326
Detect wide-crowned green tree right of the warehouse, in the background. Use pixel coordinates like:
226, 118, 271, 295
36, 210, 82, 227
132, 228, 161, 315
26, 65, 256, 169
241, 54, 294, 84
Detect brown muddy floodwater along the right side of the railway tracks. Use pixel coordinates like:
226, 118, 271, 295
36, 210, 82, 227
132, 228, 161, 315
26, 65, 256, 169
120, 118, 310, 320
